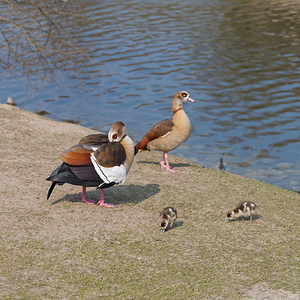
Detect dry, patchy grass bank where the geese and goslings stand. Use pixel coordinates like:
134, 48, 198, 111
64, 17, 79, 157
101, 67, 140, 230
0, 105, 300, 299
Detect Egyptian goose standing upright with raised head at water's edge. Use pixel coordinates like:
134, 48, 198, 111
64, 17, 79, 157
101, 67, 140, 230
136, 91, 195, 172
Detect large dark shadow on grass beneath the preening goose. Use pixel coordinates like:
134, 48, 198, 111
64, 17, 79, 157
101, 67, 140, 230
51, 184, 160, 205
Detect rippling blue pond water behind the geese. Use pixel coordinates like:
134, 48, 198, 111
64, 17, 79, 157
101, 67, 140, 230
0, 0, 300, 191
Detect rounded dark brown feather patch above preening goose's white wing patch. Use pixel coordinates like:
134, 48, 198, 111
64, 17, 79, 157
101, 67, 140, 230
94, 142, 126, 168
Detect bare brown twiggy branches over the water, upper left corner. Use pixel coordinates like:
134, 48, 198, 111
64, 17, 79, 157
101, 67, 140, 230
0, 0, 88, 79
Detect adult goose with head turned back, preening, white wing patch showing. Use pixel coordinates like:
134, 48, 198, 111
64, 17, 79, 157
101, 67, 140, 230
47, 121, 134, 207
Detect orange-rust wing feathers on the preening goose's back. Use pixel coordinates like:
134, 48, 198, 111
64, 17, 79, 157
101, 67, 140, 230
60, 145, 93, 166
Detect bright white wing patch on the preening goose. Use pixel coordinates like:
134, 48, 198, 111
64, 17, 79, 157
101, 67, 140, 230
91, 153, 126, 184
